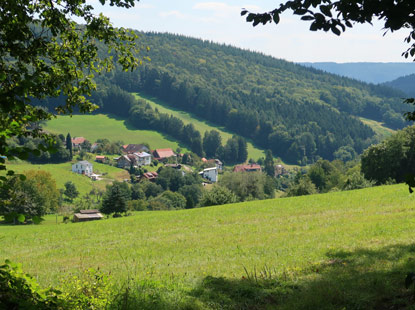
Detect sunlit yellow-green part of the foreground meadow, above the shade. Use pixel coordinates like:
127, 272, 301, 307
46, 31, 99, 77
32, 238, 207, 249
0, 185, 415, 296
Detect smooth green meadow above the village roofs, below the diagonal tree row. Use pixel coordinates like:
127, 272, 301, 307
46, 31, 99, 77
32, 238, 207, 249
43, 114, 187, 150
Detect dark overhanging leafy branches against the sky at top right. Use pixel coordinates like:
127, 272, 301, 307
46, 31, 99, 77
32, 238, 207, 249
241, 0, 415, 58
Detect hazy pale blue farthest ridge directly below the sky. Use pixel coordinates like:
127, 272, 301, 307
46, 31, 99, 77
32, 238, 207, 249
299, 62, 415, 84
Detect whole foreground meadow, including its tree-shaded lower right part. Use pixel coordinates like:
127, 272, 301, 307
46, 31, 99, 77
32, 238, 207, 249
0, 185, 415, 309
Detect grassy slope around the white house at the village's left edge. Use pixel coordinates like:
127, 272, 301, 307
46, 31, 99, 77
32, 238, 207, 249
7, 161, 129, 195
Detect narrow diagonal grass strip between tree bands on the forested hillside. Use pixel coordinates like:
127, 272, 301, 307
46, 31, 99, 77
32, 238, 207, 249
134, 93, 265, 160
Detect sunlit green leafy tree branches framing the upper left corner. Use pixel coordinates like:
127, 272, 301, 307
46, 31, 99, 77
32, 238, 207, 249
0, 0, 146, 176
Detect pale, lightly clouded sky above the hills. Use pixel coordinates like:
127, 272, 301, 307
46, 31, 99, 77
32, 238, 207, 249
92, 0, 411, 63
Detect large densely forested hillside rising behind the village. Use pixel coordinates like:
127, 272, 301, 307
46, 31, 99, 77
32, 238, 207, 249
91, 33, 408, 163
